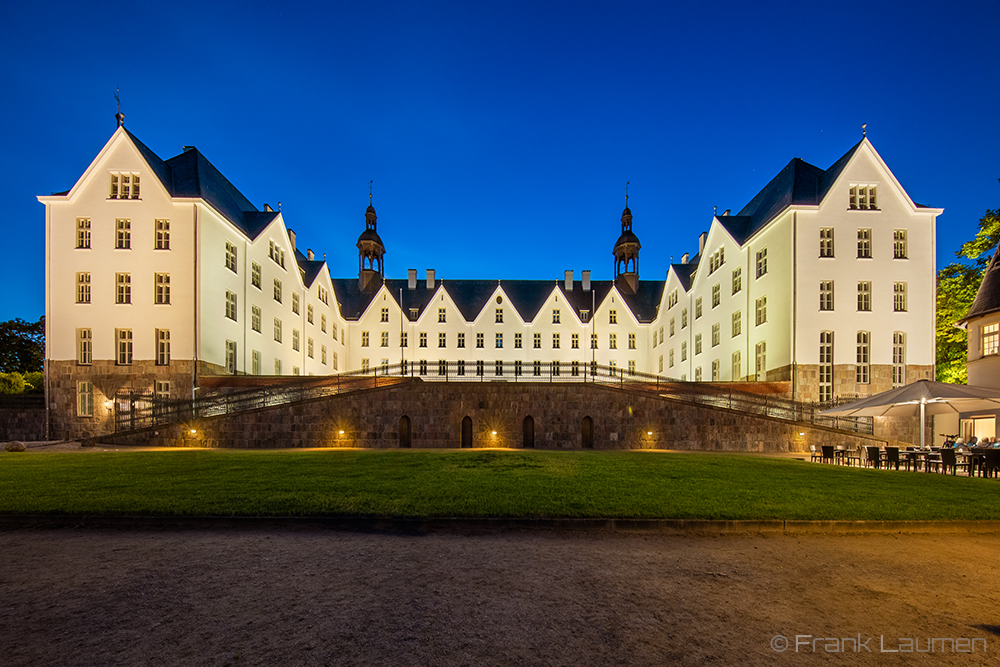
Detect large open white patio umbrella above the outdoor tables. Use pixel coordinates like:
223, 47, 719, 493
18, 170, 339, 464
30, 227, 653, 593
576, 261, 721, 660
819, 380, 1000, 449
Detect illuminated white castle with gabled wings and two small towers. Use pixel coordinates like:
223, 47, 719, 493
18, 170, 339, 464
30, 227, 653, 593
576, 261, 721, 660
38, 125, 942, 437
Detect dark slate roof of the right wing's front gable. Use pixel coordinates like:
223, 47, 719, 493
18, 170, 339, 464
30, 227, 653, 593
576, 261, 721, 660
732, 139, 865, 243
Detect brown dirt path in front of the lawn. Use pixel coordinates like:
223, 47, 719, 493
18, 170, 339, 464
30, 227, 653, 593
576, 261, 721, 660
0, 528, 1000, 667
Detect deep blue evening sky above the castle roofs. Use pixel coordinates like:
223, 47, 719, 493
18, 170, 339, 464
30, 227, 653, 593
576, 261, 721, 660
0, 0, 1000, 320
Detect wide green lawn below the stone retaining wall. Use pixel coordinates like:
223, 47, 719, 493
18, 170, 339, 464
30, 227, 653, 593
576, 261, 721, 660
0, 450, 1000, 520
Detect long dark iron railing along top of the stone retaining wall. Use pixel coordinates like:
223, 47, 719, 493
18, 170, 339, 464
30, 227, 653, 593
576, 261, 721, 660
115, 360, 874, 434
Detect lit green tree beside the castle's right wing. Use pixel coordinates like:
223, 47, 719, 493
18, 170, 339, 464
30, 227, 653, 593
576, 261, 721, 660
937, 209, 1000, 384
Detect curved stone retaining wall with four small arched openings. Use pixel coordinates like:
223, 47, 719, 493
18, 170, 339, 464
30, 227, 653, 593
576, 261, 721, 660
105, 380, 885, 452
